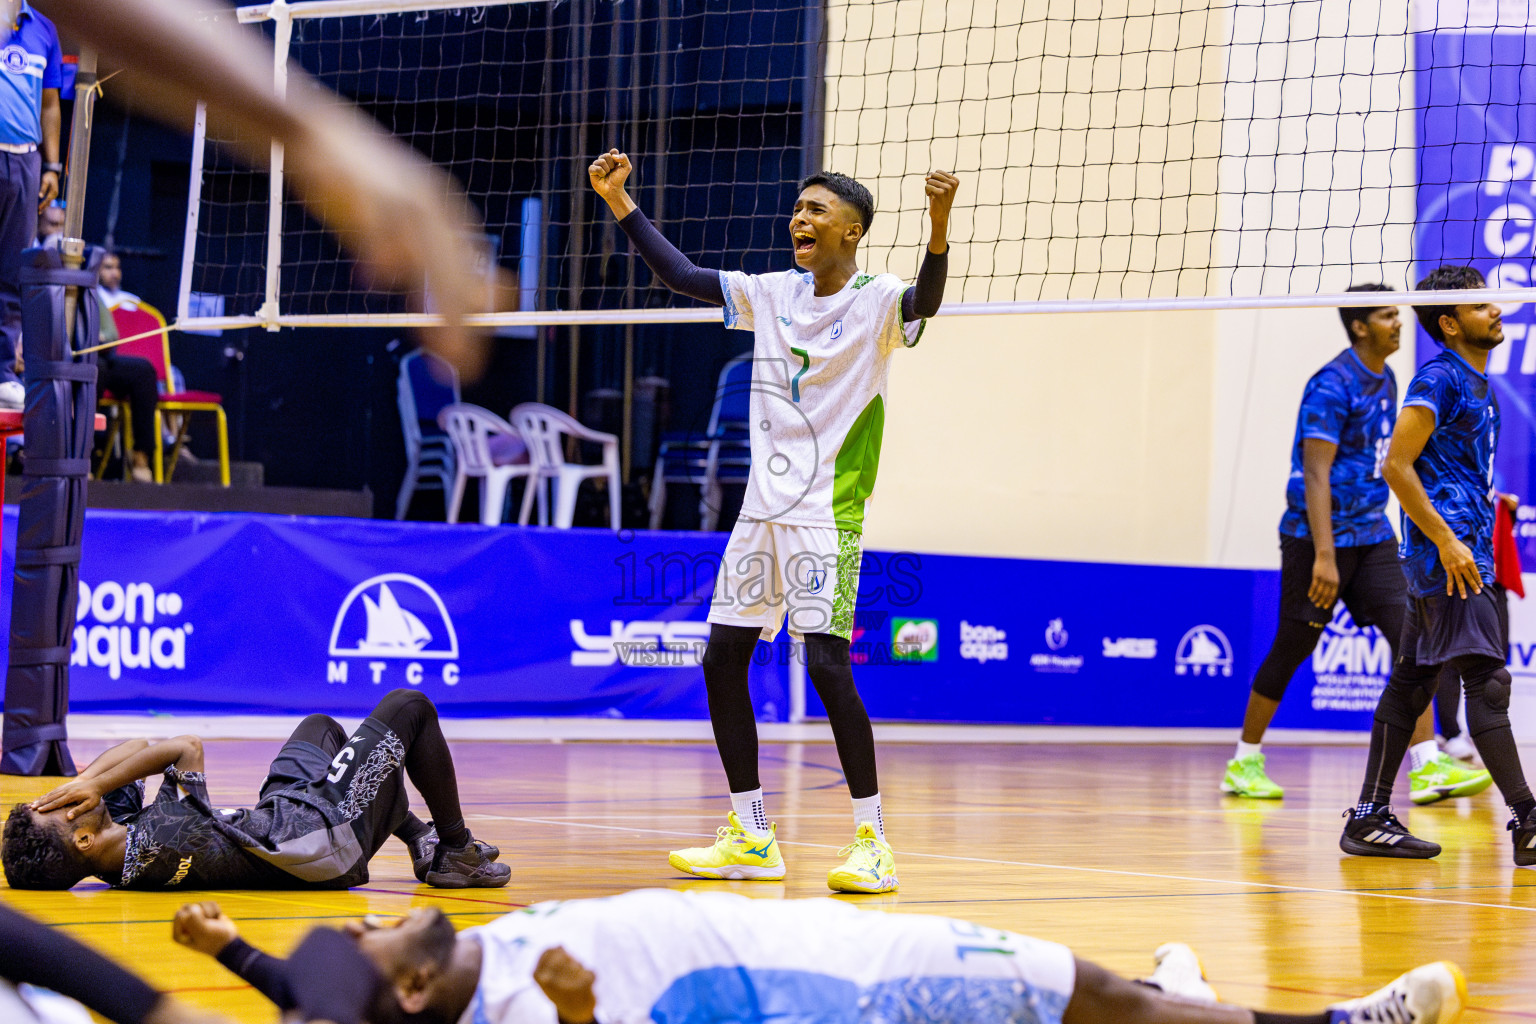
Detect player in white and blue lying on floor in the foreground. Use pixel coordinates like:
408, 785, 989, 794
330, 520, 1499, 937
172, 889, 1467, 1024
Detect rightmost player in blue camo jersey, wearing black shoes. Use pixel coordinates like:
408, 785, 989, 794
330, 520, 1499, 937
1339, 266, 1536, 864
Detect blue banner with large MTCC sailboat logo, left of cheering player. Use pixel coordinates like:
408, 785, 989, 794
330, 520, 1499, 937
0, 508, 788, 722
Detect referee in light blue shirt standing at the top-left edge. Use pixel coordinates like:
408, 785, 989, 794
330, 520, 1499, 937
0, 0, 63, 408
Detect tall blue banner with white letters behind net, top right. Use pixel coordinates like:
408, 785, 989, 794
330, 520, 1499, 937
1402, 22, 1536, 552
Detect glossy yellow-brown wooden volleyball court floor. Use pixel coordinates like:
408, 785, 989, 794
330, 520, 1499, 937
0, 742, 1536, 1024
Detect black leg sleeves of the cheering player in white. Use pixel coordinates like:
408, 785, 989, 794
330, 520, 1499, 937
703, 623, 880, 800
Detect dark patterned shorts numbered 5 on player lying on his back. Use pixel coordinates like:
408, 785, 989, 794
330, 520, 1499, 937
257, 718, 410, 886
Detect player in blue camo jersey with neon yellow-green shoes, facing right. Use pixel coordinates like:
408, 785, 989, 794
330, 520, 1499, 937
1221, 284, 1490, 803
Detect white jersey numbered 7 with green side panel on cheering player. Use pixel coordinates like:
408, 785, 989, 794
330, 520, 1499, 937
720, 270, 923, 533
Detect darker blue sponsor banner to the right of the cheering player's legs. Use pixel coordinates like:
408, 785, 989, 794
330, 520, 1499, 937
808, 553, 1392, 729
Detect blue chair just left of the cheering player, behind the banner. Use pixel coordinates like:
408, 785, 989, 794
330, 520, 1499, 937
651, 355, 753, 530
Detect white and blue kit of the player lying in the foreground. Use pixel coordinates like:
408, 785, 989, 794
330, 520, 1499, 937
459, 889, 1075, 1024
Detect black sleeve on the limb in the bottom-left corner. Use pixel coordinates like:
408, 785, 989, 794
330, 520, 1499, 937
0, 906, 160, 1024
